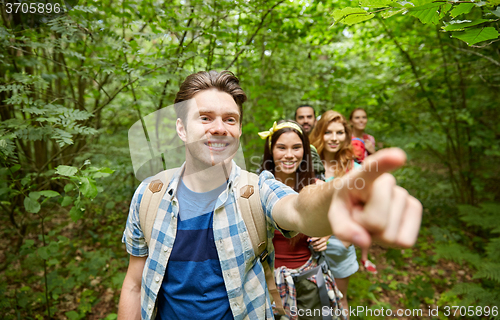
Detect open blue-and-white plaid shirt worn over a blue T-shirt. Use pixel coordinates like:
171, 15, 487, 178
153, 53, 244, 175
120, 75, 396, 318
122, 161, 296, 320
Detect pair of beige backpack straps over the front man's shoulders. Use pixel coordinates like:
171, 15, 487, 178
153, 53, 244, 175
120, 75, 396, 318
139, 168, 284, 312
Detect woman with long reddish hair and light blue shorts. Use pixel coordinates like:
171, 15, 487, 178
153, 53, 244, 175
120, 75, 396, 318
310, 110, 360, 316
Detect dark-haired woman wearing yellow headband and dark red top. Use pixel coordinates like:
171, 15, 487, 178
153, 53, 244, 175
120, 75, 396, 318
259, 120, 342, 320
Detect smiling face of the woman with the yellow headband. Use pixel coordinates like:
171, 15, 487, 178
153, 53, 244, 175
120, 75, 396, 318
273, 131, 304, 177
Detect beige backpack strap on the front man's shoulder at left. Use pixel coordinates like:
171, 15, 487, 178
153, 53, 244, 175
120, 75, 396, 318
139, 168, 179, 246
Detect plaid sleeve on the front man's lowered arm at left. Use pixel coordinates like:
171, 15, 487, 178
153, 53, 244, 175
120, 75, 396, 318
122, 180, 149, 257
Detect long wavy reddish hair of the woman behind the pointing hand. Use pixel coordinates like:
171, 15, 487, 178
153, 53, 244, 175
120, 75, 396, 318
309, 110, 354, 178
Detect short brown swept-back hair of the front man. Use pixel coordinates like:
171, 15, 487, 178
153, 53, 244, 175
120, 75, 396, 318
174, 70, 247, 125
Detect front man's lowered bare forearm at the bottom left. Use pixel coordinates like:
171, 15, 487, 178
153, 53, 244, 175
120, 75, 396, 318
118, 256, 146, 320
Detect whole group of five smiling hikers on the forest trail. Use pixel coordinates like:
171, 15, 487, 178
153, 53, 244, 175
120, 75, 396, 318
118, 71, 422, 320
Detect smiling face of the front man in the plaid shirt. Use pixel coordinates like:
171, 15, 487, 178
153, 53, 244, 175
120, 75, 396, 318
177, 89, 241, 168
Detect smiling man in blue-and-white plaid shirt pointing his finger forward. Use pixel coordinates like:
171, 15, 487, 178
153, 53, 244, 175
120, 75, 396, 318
118, 71, 422, 320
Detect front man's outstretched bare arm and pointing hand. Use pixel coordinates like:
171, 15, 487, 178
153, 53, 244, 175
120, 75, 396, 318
273, 149, 422, 247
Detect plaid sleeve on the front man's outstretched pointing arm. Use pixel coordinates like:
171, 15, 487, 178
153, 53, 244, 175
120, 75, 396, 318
259, 171, 297, 238
